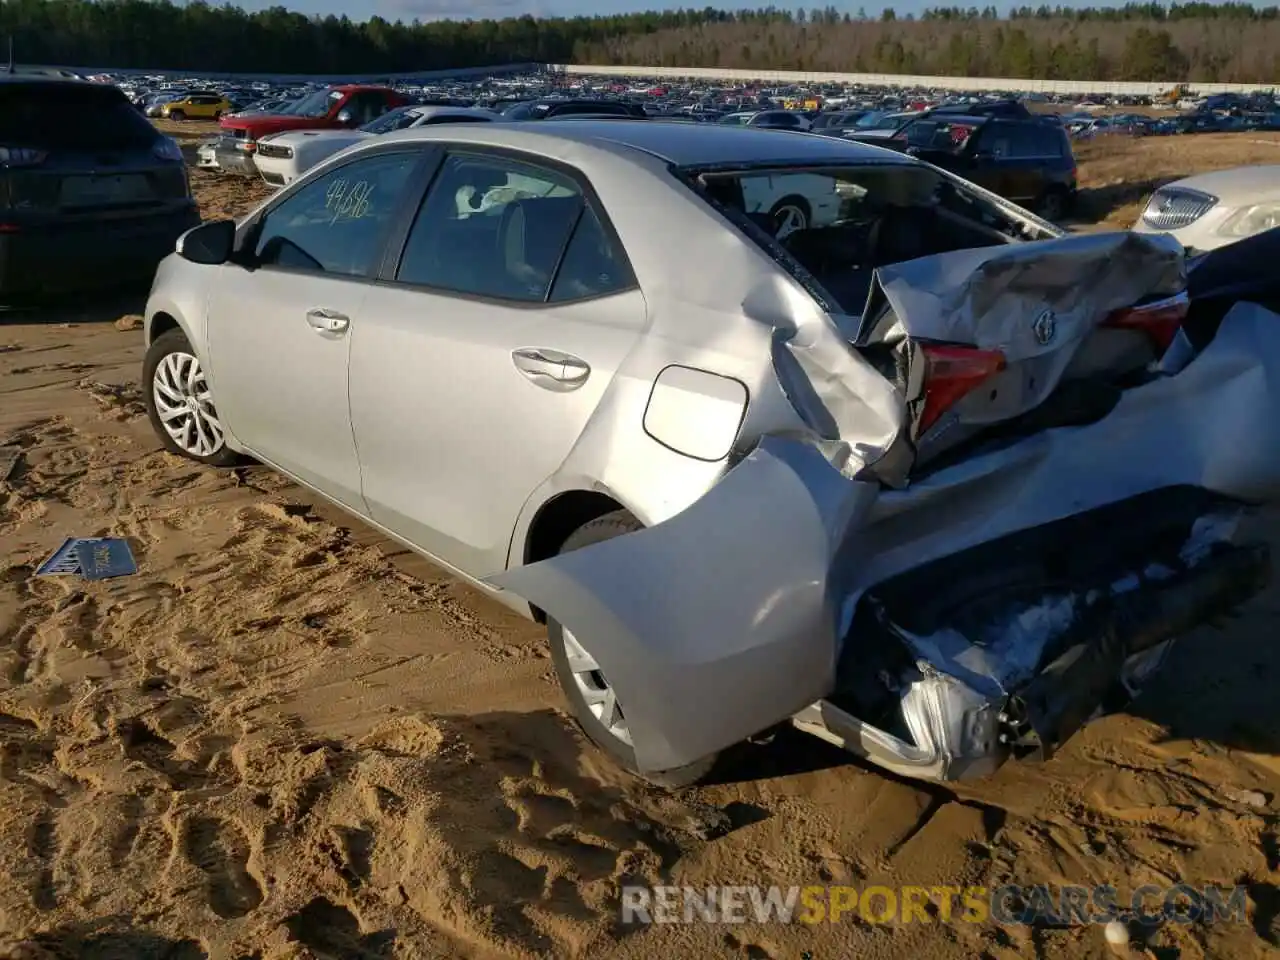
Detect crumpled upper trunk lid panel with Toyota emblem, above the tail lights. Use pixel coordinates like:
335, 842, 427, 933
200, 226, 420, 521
868, 232, 1187, 360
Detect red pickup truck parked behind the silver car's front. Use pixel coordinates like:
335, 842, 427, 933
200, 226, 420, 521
214, 83, 410, 177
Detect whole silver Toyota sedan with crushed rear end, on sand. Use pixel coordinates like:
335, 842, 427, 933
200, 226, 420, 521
143, 122, 1280, 785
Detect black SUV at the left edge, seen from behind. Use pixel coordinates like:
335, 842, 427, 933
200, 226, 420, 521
0, 74, 200, 306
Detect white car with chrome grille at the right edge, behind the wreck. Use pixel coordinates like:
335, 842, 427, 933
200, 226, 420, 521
1133, 164, 1280, 251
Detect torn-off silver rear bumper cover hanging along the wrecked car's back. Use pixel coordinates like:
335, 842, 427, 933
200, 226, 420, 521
490, 295, 1280, 771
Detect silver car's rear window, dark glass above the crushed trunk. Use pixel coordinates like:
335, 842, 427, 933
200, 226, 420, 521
686, 163, 1059, 315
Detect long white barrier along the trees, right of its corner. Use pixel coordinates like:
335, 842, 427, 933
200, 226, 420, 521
550, 64, 1277, 96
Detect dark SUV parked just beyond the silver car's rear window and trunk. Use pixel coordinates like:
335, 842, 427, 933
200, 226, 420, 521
876, 110, 1076, 220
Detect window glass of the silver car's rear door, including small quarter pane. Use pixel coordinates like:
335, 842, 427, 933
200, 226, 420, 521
396, 152, 628, 303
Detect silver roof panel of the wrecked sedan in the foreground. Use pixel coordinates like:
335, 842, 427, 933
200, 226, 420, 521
373, 119, 919, 166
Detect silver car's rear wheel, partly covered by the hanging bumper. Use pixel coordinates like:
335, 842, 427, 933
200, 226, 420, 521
547, 509, 717, 788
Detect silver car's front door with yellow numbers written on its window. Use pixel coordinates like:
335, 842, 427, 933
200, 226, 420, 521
209, 151, 421, 513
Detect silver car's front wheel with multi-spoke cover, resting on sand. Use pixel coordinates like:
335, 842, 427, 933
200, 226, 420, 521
142, 330, 239, 467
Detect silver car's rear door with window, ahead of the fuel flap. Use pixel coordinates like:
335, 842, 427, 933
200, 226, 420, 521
351, 148, 645, 571
